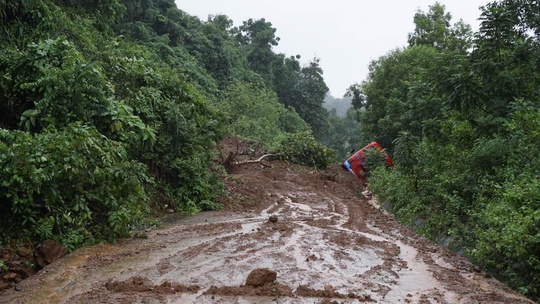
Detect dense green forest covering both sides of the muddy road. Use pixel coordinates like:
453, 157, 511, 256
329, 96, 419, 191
0, 0, 540, 299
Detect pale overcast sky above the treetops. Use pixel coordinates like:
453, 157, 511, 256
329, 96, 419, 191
175, 0, 491, 98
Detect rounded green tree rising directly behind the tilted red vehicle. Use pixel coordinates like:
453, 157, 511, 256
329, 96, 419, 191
356, 46, 442, 150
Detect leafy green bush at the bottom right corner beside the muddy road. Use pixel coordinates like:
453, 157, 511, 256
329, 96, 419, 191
469, 173, 540, 296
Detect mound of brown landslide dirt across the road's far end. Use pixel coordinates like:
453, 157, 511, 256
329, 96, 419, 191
219, 137, 365, 212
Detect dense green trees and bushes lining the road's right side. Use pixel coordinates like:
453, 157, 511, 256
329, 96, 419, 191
358, 1, 540, 300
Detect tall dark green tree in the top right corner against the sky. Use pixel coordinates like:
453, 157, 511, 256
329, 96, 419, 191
472, 3, 540, 117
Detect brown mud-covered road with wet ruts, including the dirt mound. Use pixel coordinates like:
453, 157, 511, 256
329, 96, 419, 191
0, 141, 532, 303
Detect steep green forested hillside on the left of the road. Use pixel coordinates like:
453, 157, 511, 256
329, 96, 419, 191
0, 0, 350, 251
